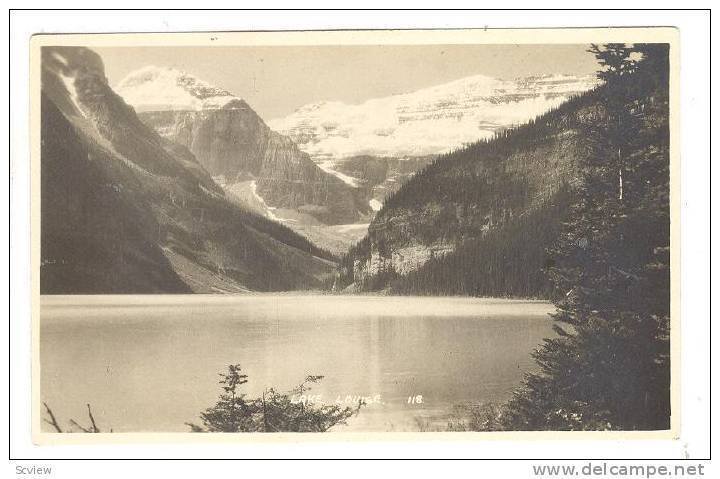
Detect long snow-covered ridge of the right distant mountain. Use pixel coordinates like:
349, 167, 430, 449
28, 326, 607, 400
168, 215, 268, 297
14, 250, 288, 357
268, 75, 596, 161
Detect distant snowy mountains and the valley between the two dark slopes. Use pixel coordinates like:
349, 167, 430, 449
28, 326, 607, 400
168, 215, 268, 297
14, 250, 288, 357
115, 66, 594, 255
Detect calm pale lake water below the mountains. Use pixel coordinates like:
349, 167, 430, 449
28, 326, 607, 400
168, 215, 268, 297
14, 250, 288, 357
40, 295, 553, 432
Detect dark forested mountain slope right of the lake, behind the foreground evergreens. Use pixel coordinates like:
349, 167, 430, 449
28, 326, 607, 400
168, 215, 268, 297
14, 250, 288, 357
336, 64, 669, 297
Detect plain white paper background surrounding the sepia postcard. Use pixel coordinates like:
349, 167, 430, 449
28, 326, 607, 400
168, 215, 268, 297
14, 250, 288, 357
5, 2, 718, 478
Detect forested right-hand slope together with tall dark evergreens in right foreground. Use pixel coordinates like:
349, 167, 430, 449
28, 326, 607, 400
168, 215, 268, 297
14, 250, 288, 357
340, 44, 671, 430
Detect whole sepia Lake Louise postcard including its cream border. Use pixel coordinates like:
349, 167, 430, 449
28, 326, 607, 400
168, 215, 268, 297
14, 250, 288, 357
31, 28, 679, 442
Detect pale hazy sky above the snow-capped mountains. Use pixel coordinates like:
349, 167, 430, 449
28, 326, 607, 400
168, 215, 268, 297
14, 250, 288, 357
94, 45, 597, 120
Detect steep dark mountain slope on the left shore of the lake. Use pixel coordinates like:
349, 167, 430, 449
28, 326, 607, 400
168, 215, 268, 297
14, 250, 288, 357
40, 47, 334, 294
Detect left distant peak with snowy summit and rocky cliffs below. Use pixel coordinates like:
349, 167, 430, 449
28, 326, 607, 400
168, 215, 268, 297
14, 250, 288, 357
115, 66, 370, 226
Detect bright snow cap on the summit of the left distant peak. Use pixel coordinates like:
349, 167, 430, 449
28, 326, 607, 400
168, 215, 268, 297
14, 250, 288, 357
114, 65, 240, 111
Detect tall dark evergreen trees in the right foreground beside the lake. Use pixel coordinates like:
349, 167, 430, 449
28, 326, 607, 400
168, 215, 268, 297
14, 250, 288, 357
474, 44, 671, 430
